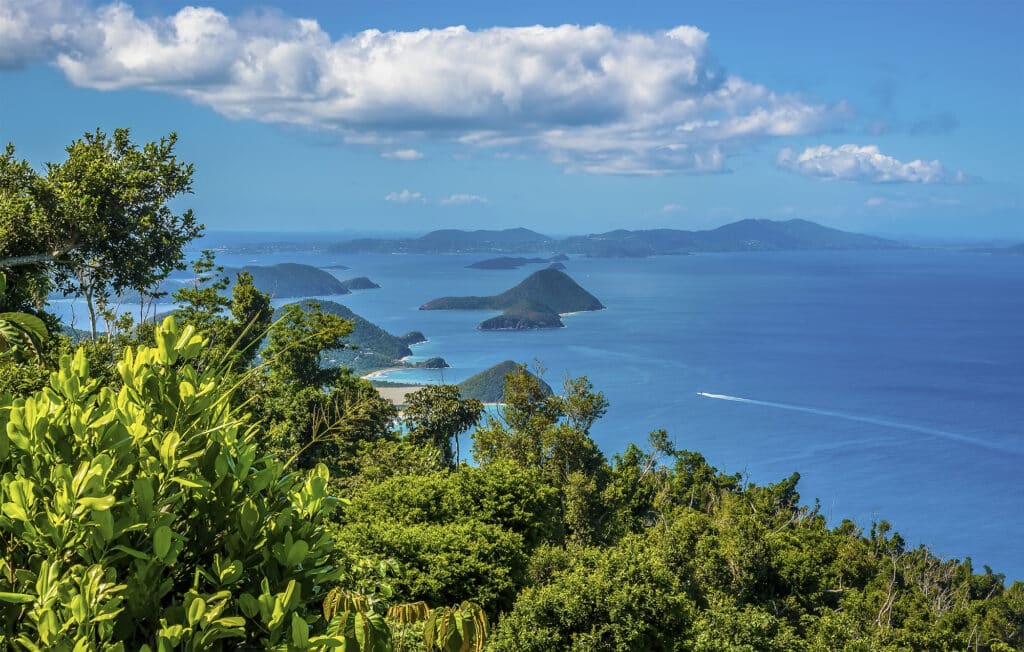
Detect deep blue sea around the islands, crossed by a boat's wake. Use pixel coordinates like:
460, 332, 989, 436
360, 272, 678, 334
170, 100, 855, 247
48, 237, 1024, 581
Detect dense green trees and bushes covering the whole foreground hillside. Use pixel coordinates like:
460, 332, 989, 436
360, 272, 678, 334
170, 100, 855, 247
0, 132, 1024, 652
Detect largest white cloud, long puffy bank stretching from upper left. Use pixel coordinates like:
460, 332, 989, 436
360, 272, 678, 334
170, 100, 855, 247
12, 0, 848, 174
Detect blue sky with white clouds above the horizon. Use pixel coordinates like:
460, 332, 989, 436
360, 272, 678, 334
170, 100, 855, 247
0, 0, 1024, 242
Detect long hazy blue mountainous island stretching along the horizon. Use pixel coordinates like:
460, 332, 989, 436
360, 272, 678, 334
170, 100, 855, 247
329, 219, 905, 261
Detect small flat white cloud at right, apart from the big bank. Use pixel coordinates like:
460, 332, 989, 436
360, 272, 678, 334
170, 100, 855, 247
777, 144, 968, 183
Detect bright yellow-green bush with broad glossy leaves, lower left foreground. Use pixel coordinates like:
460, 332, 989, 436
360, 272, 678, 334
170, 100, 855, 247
0, 319, 348, 650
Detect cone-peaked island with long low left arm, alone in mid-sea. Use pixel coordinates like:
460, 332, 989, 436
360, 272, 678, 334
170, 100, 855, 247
420, 269, 604, 331
